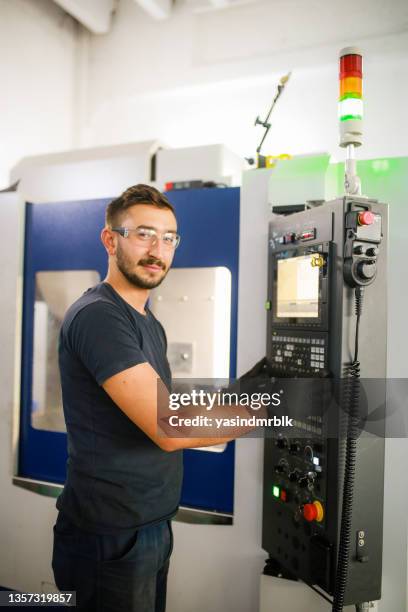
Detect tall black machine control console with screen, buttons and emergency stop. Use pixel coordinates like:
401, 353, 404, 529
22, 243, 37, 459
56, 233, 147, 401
262, 197, 387, 605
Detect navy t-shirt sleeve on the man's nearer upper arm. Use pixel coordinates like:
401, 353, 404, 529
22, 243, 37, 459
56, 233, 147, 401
67, 301, 147, 385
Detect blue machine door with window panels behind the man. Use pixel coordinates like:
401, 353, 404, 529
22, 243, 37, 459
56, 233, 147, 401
19, 188, 239, 513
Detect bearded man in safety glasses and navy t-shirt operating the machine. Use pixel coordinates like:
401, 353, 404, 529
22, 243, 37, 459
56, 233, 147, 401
53, 185, 264, 612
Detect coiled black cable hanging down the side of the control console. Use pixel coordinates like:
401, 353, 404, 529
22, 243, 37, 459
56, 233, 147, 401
332, 287, 364, 612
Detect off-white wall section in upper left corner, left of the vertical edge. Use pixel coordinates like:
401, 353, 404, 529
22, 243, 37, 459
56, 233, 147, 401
0, 0, 79, 189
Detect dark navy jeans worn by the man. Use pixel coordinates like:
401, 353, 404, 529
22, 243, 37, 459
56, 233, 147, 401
52, 512, 173, 612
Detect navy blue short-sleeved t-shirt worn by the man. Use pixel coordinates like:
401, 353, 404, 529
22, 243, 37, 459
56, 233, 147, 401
57, 282, 182, 533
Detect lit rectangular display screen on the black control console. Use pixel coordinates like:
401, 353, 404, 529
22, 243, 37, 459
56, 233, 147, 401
276, 253, 319, 319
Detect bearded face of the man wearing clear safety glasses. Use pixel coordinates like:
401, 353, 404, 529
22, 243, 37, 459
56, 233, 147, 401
116, 204, 177, 289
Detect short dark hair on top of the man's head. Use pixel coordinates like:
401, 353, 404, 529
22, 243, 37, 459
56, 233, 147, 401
105, 183, 175, 227
